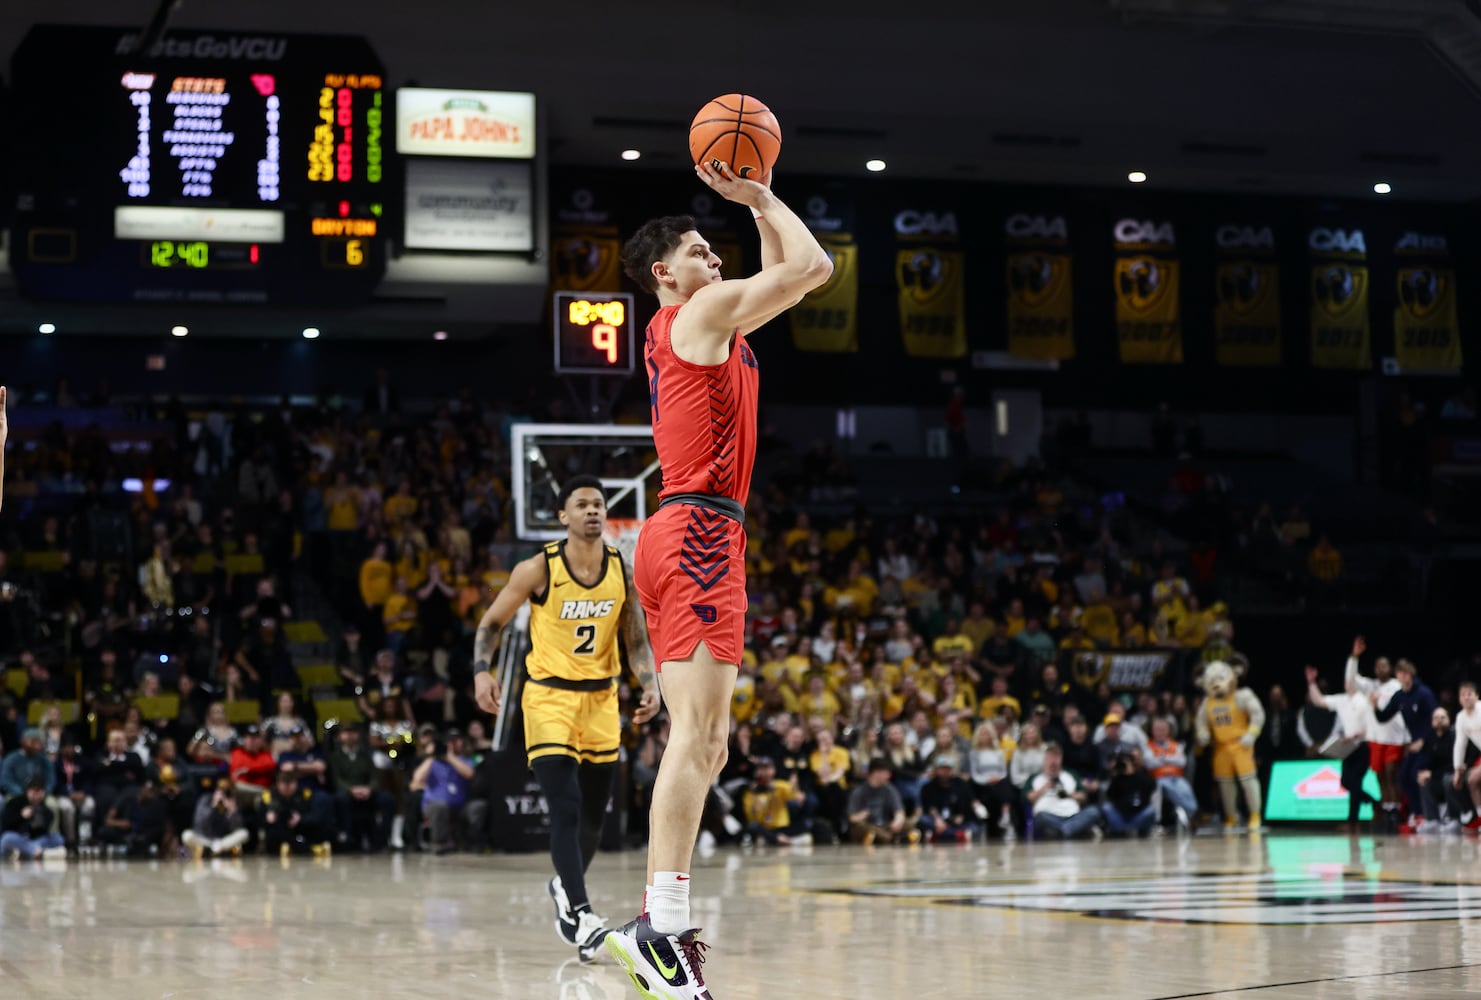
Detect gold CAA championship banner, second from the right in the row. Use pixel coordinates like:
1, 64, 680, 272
1306, 227, 1373, 370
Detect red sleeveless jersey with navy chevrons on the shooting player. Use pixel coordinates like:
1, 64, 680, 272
644, 305, 760, 505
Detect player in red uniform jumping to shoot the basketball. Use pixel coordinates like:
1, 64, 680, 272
607, 161, 832, 1000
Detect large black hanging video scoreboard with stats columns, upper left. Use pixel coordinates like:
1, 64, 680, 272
7, 25, 390, 305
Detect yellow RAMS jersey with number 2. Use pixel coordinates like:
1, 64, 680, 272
524, 541, 626, 680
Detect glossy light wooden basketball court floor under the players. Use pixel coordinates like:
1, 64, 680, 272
0, 834, 1481, 1000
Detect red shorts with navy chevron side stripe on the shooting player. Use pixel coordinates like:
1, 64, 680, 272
632, 504, 746, 667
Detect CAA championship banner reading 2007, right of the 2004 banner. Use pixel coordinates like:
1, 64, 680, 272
1114, 219, 1183, 364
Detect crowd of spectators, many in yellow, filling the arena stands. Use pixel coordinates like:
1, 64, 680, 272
0, 381, 1481, 856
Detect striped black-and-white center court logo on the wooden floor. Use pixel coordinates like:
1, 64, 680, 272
850, 870, 1481, 926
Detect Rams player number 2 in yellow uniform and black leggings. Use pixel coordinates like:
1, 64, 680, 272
472, 476, 659, 961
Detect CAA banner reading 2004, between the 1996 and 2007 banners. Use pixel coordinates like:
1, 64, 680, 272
1003, 213, 1075, 361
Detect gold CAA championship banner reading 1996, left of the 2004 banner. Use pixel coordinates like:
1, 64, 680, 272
895, 209, 967, 359
